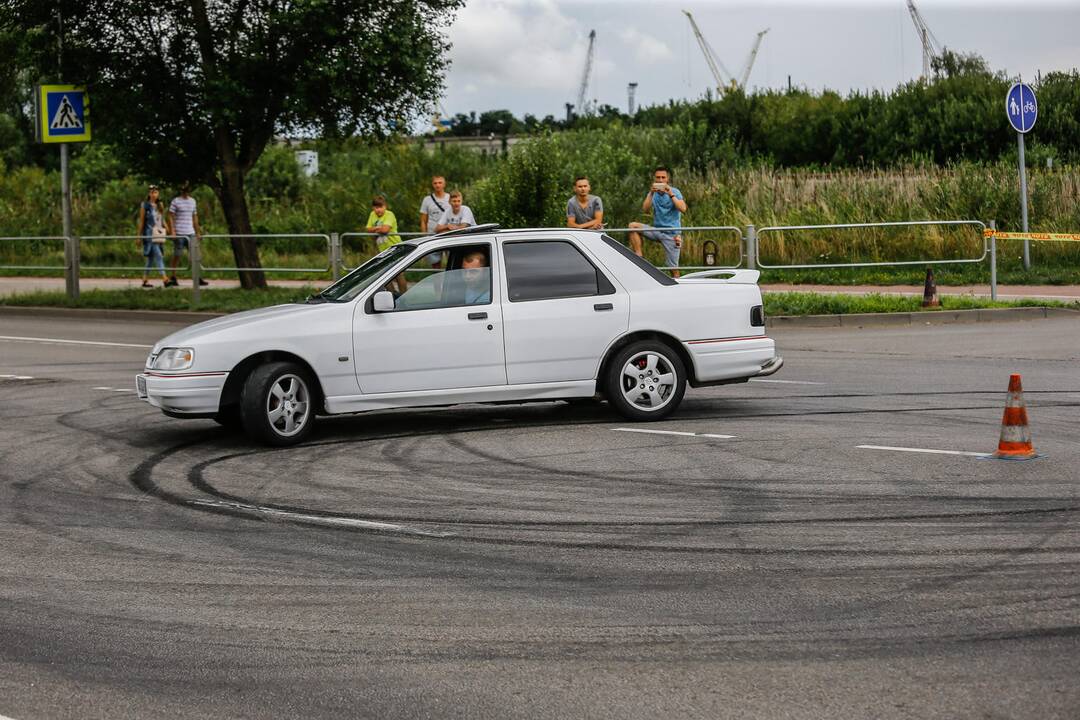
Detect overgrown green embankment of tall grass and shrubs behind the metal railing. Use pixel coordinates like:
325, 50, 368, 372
0, 127, 1080, 285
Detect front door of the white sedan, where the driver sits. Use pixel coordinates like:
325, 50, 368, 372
353, 241, 507, 395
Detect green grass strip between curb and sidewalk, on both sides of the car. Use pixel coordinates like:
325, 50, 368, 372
0, 287, 1080, 315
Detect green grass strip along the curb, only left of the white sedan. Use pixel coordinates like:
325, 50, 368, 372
0, 287, 316, 313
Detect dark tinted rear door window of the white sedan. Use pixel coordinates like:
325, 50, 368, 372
502, 241, 615, 302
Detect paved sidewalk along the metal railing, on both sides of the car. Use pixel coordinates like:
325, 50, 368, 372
0, 277, 1080, 302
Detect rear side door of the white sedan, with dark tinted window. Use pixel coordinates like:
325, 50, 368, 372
500, 239, 630, 385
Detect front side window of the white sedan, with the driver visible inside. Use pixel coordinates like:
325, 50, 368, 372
384, 244, 491, 310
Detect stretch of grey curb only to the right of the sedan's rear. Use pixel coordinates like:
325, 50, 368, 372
765, 308, 1080, 327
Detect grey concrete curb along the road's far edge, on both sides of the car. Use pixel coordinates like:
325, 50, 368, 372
0, 304, 1080, 327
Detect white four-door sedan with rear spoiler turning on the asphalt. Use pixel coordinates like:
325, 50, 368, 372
136, 226, 783, 445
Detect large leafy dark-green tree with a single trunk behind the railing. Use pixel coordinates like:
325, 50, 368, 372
0, 0, 463, 287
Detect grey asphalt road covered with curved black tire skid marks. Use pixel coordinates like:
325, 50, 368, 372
0, 315, 1080, 720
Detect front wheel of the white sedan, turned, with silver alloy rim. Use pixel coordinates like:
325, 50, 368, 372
240, 363, 318, 447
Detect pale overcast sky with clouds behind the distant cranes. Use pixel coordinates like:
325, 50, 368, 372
443, 0, 1080, 118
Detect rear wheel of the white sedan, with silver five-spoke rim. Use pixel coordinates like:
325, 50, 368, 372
604, 340, 686, 422
